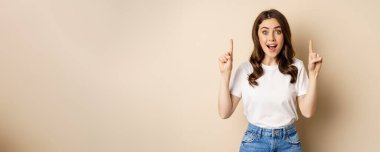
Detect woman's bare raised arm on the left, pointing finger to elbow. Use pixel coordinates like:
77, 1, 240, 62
218, 39, 240, 119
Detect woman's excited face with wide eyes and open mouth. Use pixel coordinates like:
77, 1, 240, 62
257, 18, 284, 59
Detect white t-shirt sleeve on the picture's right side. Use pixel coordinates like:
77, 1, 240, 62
296, 61, 309, 96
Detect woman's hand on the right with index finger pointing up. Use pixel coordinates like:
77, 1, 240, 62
308, 40, 322, 78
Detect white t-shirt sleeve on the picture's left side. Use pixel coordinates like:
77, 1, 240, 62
230, 64, 248, 97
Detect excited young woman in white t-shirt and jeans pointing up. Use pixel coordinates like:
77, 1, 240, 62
218, 9, 322, 152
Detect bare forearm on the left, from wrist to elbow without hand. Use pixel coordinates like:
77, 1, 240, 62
218, 73, 233, 119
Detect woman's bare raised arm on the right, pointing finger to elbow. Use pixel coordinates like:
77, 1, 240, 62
297, 40, 322, 118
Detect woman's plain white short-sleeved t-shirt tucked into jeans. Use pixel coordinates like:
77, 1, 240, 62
230, 58, 309, 128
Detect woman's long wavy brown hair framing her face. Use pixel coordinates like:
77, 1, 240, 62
248, 9, 298, 87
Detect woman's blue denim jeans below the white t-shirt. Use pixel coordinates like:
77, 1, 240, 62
240, 123, 302, 152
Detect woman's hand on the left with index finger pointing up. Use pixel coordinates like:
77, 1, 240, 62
219, 39, 234, 75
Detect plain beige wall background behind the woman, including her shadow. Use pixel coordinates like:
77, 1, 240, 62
0, 0, 380, 152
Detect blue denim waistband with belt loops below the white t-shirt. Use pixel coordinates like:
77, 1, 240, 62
247, 123, 297, 138
